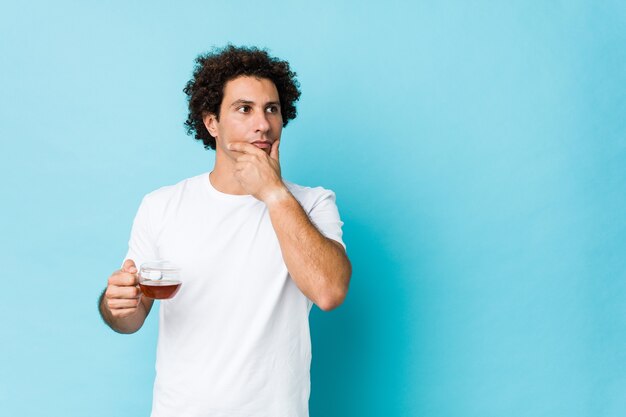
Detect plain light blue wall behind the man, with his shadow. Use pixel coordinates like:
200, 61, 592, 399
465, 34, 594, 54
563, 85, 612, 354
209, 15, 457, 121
0, 1, 626, 417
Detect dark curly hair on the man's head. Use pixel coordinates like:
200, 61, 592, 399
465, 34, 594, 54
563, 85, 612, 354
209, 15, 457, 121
183, 44, 300, 149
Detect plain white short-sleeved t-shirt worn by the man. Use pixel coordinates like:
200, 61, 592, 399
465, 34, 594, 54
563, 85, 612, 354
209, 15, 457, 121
126, 173, 345, 417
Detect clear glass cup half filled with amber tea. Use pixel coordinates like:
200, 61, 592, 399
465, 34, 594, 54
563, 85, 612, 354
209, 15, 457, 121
139, 261, 182, 300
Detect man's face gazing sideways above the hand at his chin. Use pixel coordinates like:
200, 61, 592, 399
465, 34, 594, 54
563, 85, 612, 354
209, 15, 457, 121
204, 76, 283, 159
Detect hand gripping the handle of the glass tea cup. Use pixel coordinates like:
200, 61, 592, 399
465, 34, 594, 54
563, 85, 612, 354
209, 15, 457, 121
103, 259, 141, 318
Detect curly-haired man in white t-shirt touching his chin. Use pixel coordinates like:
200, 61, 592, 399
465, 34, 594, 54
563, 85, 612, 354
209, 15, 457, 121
100, 45, 351, 417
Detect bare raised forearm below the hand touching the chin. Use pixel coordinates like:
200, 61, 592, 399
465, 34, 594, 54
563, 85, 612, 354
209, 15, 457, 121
266, 189, 352, 310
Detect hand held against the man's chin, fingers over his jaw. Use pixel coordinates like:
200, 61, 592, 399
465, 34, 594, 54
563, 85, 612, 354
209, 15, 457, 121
228, 140, 288, 204
